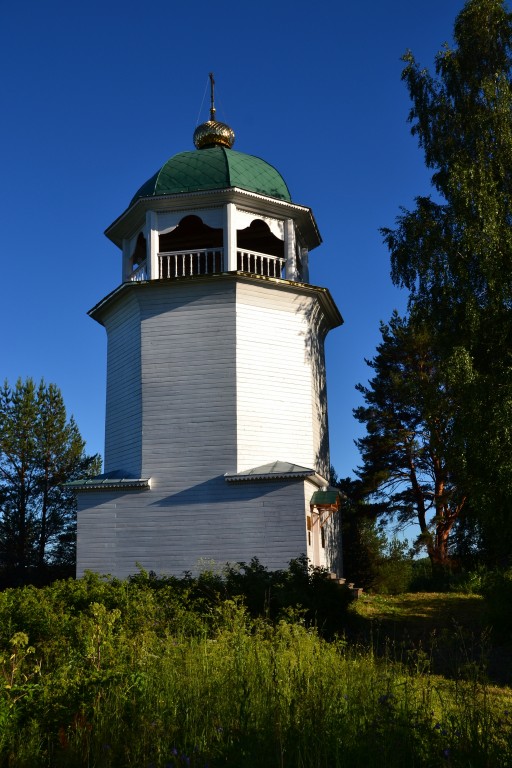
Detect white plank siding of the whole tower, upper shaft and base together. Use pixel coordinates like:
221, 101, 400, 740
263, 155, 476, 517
77, 275, 340, 577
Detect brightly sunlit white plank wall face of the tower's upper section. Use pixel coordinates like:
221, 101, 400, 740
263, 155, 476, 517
236, 283, 328, 473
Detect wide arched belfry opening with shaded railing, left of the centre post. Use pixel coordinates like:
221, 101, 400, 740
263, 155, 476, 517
158, 215, 224, 278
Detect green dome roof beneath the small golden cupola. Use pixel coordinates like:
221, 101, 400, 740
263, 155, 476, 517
130, 146, 291, 205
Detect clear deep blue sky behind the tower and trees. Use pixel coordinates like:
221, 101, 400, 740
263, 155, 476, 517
0, 0, 463, 476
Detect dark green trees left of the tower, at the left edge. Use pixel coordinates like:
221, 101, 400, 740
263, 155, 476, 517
0, 379, 99, 583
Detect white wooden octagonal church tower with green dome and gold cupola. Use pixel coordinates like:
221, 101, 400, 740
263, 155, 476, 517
71, 79, 342, 577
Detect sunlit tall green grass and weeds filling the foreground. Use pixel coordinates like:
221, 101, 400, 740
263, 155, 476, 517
0, 579, 512, 768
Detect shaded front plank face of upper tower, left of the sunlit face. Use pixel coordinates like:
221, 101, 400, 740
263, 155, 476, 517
140, 281, 236, 486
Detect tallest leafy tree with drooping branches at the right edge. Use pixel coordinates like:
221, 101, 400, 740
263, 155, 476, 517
383, 0, 512, 564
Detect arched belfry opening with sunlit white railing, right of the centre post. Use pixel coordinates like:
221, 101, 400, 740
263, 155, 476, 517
236, 219, 285, 277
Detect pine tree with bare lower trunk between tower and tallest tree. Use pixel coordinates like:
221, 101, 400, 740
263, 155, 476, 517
354, 312, 466, 569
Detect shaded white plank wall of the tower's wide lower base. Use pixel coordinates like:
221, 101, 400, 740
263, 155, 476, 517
77, 481, 306, 578
